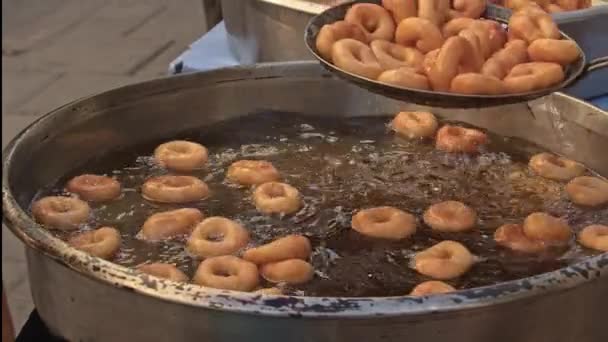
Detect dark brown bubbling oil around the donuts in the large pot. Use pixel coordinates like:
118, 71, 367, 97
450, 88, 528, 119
41, 112, 608, 297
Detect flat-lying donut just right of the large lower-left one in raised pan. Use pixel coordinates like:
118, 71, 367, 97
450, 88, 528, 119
370, 40, 424, 71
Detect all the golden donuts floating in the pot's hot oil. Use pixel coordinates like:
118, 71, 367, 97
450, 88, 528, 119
31, 117, 608, 296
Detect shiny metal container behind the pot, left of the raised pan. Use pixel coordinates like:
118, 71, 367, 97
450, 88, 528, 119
222, 0, 348, 64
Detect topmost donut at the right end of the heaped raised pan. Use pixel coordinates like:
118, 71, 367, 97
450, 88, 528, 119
509, 11, 561, 44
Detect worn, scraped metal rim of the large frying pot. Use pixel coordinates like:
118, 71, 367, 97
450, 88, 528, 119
2, 62, 608, 318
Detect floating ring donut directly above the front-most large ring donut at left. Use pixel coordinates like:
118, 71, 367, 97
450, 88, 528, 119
186, 216, 249, 258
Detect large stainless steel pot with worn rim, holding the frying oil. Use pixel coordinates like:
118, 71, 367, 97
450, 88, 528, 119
2, 62, 608, 342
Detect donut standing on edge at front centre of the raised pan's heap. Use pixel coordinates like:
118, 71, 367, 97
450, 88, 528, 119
427, 36, 480, 91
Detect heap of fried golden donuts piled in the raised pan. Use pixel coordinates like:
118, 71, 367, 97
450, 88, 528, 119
316, 0, 580, 95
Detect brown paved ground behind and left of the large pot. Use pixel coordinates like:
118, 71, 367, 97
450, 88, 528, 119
2, 0, 205, 329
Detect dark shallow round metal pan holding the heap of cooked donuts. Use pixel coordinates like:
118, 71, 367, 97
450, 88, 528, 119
305, 0, 608, 108
